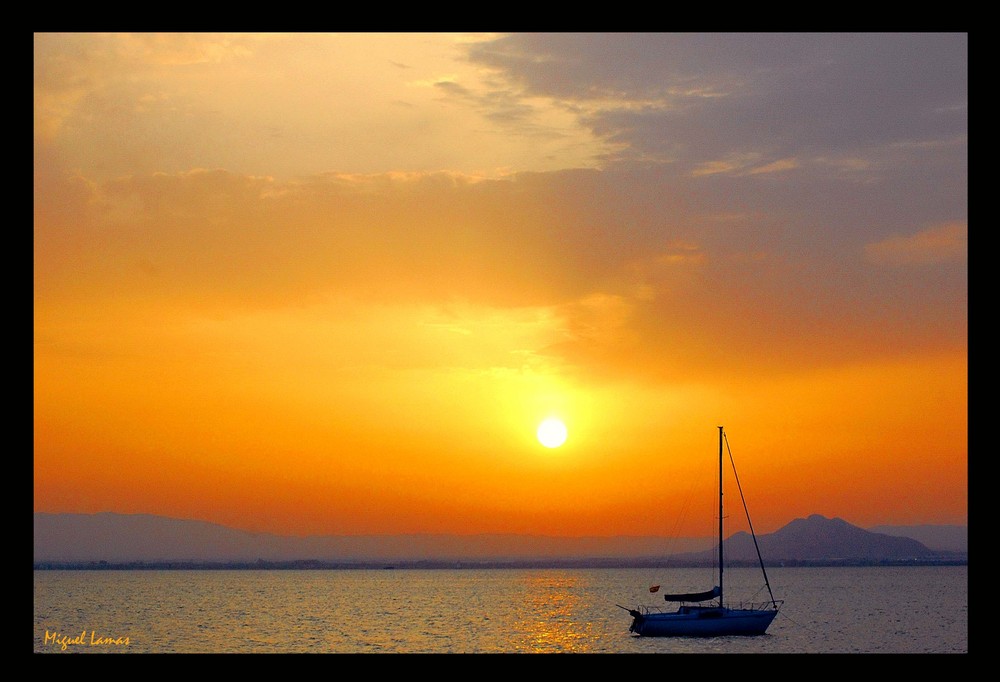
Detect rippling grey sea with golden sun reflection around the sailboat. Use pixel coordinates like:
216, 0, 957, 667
34, 566, 969, 654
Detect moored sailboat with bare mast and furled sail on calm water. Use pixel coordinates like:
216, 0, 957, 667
618, 426, 783, 637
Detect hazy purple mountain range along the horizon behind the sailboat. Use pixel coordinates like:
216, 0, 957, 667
34, 512, 964, 565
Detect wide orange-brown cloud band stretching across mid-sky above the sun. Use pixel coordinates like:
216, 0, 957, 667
36, 160, 964, 390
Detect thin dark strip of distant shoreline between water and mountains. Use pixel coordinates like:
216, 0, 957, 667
33, 557, 969, 571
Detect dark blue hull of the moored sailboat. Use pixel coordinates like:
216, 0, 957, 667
629, 606, 778, 637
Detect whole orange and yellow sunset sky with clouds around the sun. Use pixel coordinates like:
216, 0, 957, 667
34, 33, 969, 536
